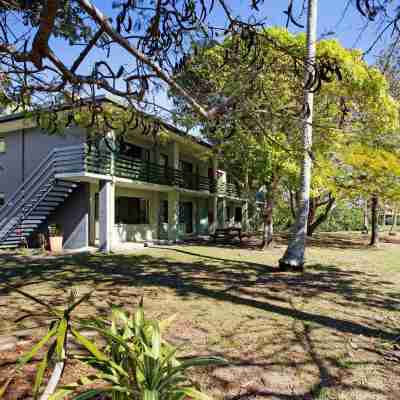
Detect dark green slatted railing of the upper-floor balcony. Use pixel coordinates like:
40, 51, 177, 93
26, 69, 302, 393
57, 146, 216, 193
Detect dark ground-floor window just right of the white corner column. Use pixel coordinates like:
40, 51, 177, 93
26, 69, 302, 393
115, 197, 150, 225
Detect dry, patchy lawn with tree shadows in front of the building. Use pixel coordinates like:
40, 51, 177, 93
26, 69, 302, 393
0, 235, 400, 400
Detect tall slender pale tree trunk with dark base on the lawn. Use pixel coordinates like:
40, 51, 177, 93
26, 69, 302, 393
279, 0, 318, 271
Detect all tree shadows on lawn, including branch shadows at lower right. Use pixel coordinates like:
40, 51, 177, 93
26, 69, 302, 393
0, 247, 400, 400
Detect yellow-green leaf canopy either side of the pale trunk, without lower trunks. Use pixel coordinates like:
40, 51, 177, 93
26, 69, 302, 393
170, 28, 400, 216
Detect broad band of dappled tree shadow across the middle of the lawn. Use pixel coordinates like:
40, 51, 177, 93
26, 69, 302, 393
0, 249, 400, 340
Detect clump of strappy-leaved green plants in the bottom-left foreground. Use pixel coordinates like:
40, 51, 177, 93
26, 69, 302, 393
0, 292, 226, 400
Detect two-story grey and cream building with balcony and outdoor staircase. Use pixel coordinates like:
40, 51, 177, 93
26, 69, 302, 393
0, 97, 247, 251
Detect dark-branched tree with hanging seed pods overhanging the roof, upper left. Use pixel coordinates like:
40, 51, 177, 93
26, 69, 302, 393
0, 0, 398, 125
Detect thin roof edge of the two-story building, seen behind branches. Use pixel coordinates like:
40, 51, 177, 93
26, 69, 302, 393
0, 94, 213, 149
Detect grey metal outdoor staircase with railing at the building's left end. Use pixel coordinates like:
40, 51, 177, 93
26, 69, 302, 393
0, 146, 84, 248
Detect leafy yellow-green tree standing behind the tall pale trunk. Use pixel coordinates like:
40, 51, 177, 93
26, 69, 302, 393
171, 17, 396, 258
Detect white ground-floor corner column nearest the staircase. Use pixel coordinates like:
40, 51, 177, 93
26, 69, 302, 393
99, 180, 115, 253
